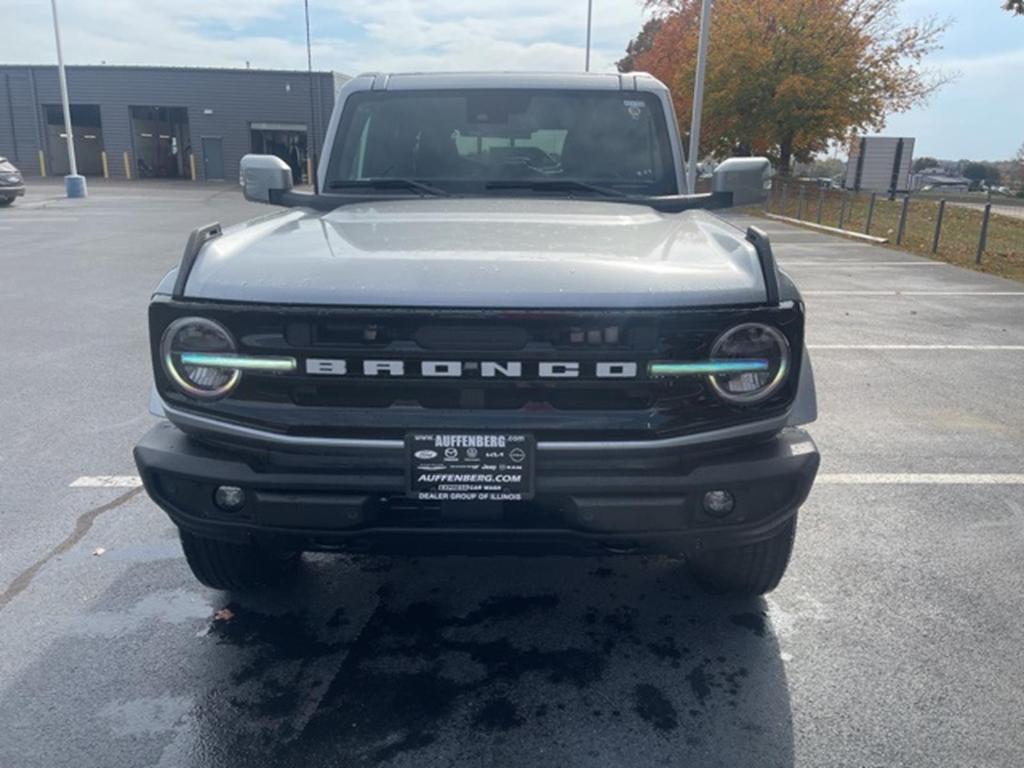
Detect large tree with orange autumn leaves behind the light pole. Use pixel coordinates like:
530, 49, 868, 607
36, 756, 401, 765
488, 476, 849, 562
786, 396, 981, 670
620, 0, 949, 174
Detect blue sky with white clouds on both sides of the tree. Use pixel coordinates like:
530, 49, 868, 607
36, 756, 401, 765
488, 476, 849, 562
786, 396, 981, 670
0, 0, 1024, 160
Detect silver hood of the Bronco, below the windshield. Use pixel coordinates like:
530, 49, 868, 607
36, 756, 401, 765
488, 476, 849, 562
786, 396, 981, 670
185, 198, 765, 309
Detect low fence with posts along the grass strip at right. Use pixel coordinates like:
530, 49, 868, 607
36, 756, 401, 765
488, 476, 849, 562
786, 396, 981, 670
765, 181, 1024, 274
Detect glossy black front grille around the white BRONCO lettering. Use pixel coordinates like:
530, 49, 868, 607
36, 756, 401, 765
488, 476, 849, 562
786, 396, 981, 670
151, 300, 803, 439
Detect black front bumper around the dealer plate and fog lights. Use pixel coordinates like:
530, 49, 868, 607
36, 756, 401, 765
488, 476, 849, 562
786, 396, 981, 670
135, 422, 819, 554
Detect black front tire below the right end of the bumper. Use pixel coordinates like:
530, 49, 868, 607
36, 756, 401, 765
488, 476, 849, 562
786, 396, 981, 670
687, 514, 797, 596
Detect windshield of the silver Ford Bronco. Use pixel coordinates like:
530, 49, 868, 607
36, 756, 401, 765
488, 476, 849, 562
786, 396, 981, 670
327, 89, 677, 197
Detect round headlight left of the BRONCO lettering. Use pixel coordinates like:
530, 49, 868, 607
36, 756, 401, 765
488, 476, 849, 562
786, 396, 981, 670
160, 317, 242, 399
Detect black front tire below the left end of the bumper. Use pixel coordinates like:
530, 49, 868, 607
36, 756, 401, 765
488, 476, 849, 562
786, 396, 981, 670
179, 530, 301, 590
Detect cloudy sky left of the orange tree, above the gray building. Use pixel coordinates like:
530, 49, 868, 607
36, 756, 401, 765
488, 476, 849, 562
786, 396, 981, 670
0, 0, 642, 73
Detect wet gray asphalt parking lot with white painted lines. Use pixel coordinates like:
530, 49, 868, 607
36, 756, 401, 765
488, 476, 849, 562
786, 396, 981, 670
0, 182, 1024, 768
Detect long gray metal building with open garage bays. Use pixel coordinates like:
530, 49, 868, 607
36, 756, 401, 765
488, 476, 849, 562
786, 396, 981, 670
0, 65, 348, 182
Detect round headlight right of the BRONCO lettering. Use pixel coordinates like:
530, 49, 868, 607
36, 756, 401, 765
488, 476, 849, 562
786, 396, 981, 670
708, 323, 790, 404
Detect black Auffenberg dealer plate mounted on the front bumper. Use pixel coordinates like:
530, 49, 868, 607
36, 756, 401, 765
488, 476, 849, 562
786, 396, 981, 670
406, 432, 534, 502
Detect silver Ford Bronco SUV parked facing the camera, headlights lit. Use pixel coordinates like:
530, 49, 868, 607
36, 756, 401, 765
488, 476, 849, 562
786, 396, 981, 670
135, 74, 819, 594
